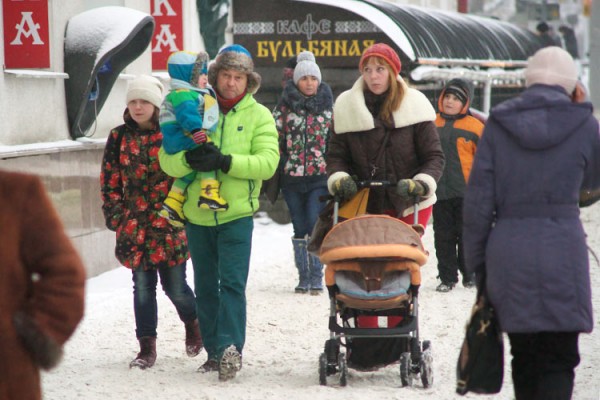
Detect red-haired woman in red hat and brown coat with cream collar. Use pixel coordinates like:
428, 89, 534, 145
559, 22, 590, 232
327, 43, 444, 226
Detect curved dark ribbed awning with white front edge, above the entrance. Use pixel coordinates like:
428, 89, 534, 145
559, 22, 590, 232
296, 0, 541, 67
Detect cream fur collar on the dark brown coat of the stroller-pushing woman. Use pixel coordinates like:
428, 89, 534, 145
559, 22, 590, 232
333, 76, 435, 133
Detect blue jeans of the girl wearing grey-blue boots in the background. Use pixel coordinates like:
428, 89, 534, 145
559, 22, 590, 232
282, 186, 328, 239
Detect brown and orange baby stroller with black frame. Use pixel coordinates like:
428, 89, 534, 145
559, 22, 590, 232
319, 190, 433, 388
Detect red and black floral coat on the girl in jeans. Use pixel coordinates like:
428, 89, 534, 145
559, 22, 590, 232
100, 112, 189, 270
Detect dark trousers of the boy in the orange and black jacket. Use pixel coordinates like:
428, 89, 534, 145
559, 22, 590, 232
433, 197, 471, 283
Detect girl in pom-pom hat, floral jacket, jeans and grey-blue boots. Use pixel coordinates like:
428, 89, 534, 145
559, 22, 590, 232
273, 51, 333, 294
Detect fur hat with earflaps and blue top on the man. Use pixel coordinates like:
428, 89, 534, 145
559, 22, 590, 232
208, 44, 261, 94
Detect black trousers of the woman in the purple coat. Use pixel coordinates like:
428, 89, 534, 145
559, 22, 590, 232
508, 332, 579, 400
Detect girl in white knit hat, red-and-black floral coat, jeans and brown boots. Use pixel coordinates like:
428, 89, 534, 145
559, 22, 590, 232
100, 76, 203, 369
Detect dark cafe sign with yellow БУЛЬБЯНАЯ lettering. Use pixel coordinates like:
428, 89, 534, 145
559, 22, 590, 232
233, 0, 389, 68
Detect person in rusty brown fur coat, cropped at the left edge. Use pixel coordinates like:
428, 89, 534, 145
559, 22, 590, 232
0, 171, 85, 400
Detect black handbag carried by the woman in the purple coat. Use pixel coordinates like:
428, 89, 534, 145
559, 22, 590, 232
456, 278, 504, 395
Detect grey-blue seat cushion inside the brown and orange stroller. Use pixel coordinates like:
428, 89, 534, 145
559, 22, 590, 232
335, 271, 410, 300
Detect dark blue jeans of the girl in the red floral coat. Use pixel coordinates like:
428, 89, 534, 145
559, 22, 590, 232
132, 263, 196, 339
